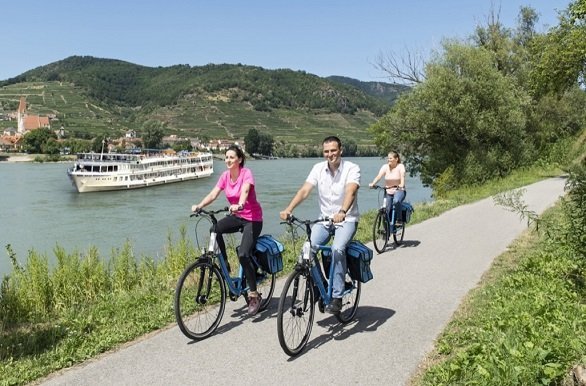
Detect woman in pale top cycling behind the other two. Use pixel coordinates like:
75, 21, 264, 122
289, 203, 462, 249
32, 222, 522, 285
368, 151, 407, 231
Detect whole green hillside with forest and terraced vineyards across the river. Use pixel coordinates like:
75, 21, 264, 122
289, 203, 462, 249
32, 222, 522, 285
0, 56, 404, 144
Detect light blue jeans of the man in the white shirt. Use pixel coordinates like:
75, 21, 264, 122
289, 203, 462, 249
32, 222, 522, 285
311, 221, 358, 298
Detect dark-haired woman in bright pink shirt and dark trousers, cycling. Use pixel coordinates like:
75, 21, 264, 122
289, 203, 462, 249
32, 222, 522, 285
191, 145, 262, 315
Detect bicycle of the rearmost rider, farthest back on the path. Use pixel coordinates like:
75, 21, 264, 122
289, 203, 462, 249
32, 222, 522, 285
372, 185, 406, 253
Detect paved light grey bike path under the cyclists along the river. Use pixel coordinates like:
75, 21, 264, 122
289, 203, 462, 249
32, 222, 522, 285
37, 178, 565, 385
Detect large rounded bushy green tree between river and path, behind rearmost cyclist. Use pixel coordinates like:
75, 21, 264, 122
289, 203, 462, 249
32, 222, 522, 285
371, 41, 529, 190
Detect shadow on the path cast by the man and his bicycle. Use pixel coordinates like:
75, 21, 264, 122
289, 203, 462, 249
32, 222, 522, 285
288, 306, 396, 361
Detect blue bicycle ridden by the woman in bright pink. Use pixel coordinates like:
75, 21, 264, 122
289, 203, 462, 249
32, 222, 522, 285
174, 208, 275, 340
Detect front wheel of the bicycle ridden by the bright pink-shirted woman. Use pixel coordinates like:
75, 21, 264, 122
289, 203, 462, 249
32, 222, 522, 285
174, 261, 226, 340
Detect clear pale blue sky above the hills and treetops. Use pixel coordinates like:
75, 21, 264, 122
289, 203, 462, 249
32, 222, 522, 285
0, 0, 570, 81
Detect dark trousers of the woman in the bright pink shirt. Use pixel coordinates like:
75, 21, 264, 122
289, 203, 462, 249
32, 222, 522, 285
216, 216, 262, 291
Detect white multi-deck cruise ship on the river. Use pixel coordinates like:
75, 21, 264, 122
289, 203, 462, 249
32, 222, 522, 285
67, 152, 214, 193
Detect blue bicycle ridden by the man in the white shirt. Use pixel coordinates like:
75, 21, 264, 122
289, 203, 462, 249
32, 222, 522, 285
277, 215, 361, 356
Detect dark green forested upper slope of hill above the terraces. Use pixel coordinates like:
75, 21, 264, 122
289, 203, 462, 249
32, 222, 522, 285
0, 56, 389, 116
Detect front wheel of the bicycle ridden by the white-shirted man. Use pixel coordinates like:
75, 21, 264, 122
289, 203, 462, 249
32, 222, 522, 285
277, 269, 315, 356
